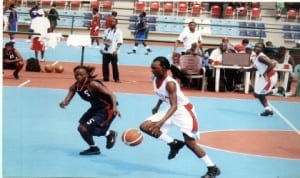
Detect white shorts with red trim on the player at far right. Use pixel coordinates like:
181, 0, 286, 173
254, 72, 278, 95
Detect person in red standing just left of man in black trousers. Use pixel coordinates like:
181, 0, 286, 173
90, 8, 101, 48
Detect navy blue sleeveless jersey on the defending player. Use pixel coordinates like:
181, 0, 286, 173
76, 79, 113, 109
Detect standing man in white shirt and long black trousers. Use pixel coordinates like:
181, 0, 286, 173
100, 19, 123, 83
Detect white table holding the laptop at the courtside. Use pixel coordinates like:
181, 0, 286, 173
213, 65, 252, 93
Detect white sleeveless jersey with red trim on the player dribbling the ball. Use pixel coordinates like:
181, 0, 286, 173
153, 76, 190, 106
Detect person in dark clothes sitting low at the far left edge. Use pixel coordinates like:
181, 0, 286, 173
2, 42, 24, 79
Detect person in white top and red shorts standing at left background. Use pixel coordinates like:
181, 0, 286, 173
30, 9, 50, 62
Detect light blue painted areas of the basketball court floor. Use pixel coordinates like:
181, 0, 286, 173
2, 38, 300, 178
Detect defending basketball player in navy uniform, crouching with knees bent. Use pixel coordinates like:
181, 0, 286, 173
59, 65, 121, 155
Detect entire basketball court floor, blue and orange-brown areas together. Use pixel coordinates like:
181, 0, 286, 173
2, 39, 300, 178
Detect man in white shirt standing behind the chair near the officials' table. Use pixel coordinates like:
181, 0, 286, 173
173, 21, 202, 54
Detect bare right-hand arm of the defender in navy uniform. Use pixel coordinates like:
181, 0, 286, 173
90, 81, 121, 117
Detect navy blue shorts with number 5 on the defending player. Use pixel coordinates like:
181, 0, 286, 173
79, 108, 115, 136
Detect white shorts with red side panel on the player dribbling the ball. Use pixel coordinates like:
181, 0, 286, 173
146, 104, 200, 139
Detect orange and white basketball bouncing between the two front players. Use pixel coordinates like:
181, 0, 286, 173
122, 128, 143, 146
